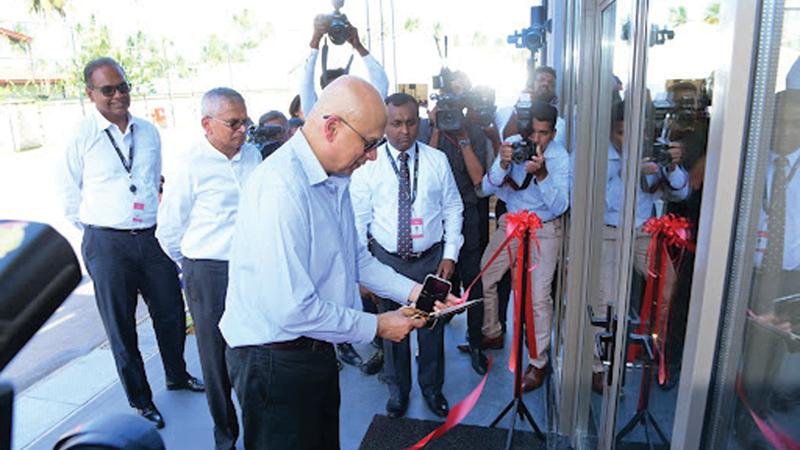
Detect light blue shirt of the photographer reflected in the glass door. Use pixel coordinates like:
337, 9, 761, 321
603, 144, 689, 228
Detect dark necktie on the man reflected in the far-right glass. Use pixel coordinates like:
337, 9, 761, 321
761, 156, 789, 273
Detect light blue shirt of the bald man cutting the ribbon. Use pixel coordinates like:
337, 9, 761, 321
219, 130, 416, 347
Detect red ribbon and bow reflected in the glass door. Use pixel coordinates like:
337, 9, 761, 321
630, 214, 695, 384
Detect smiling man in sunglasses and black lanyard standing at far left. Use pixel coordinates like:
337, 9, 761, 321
58, 57, 204, 428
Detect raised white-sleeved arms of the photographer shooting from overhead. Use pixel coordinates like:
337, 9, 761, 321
300, 14, 389, 117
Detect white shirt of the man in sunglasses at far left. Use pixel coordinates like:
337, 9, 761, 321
56, 109, 161, 229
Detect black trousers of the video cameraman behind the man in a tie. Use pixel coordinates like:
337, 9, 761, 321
451, 204, 488, 348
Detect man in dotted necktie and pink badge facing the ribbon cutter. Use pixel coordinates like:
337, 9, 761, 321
351, 93, 464, 418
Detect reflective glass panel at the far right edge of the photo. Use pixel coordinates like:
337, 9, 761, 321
715, 1, 800, 449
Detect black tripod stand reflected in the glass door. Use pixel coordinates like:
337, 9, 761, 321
616, 236, 669, 450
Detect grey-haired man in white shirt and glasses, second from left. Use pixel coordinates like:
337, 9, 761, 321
156, 87, 260, 450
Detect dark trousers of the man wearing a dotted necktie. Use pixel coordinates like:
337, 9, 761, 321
370, 241, 444, 397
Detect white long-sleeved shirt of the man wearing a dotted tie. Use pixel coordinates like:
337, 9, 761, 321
350, 141, 464, 261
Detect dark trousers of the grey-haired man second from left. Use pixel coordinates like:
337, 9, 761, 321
183, 258, 239, 450
